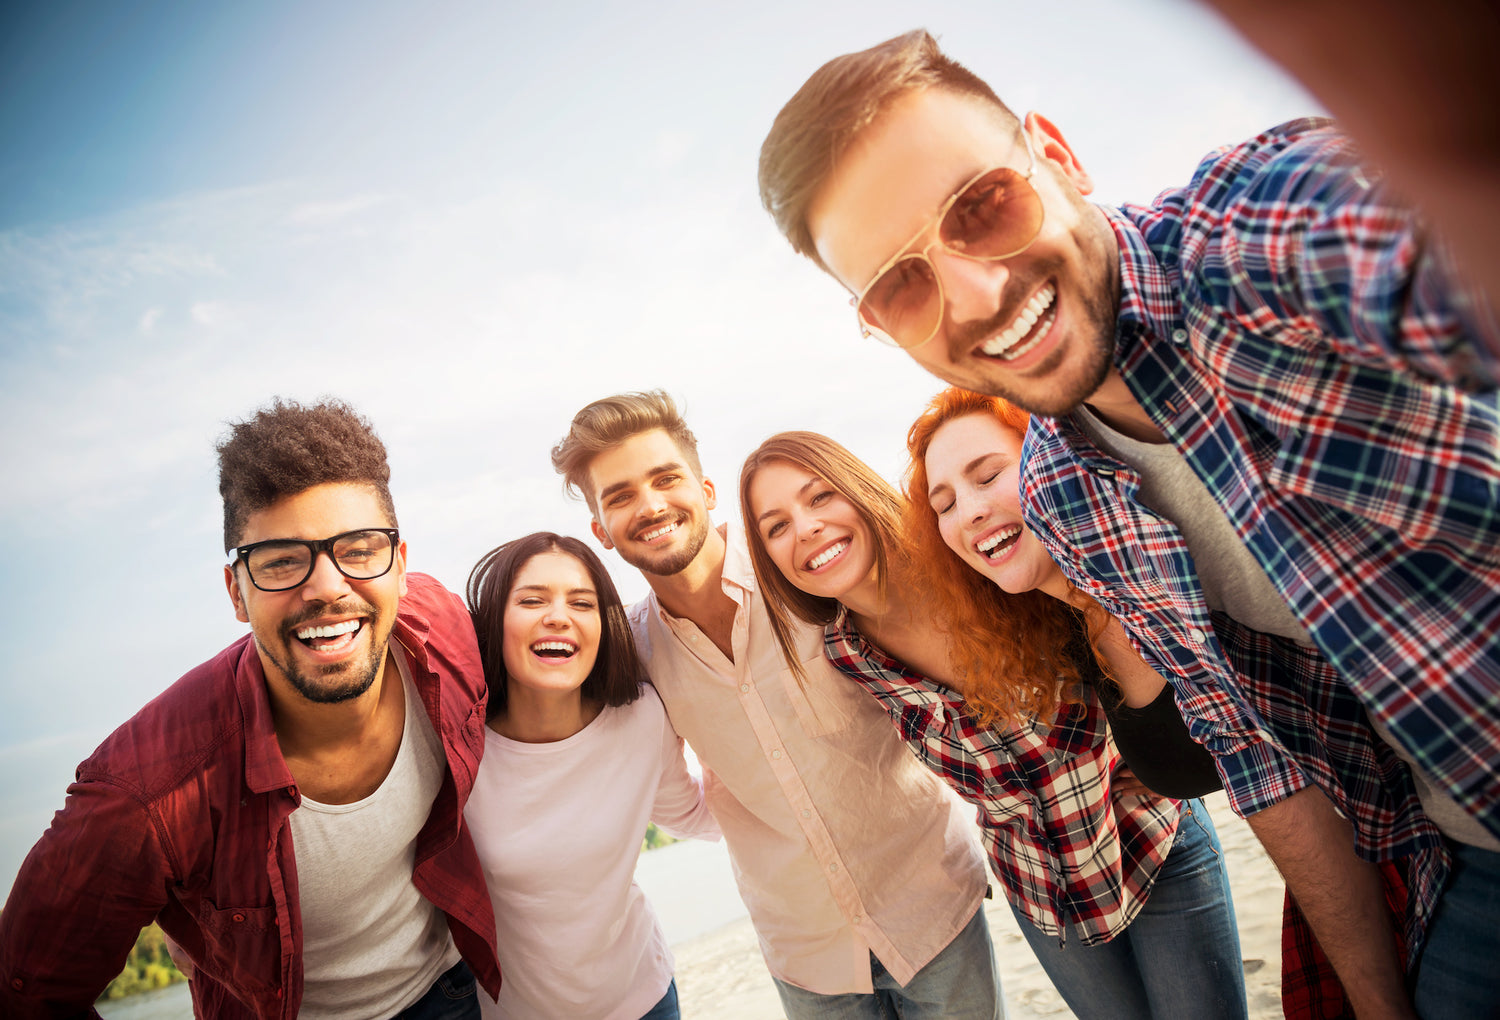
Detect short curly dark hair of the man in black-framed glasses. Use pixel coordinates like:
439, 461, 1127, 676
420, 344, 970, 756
218, 398, 399, 552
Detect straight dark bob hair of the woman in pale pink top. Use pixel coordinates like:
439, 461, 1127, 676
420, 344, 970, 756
464, 531, 650, 719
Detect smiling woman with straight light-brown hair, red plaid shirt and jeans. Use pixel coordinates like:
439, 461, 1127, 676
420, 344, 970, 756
740, 432, 1247, 1020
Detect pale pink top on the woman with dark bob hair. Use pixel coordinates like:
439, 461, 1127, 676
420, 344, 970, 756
464, 686, 719, 1020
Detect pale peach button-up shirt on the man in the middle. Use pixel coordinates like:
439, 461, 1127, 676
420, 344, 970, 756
630, 524, 986, 995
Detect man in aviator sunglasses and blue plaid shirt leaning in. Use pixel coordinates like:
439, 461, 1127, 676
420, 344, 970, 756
761, 32, 1500, 1017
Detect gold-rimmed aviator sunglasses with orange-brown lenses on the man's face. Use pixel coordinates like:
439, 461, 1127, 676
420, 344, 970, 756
851, 132, 1043, 350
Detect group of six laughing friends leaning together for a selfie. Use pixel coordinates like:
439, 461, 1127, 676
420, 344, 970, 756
0, 21, 1500, 1020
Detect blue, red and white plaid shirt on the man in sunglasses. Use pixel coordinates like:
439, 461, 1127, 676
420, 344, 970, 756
1022, 120, 1464, 947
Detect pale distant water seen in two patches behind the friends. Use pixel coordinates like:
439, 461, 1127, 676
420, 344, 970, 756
90, 840, 746, 1020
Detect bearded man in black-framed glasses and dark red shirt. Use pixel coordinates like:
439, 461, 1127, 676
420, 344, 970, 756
0, 402, 500, 1020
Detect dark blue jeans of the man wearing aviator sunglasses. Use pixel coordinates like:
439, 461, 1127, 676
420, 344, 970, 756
1415, 843, 1500, 1020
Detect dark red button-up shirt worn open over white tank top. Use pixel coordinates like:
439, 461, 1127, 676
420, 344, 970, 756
0, 575, 500, 1020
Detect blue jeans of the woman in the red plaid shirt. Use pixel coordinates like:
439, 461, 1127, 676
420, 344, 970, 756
1011, 801, 1248, 1020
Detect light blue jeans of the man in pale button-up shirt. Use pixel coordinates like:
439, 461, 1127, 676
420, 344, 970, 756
776, 906, 1005, 1020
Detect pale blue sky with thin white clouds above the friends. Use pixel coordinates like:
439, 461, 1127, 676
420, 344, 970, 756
0, 0, 1319, 888
